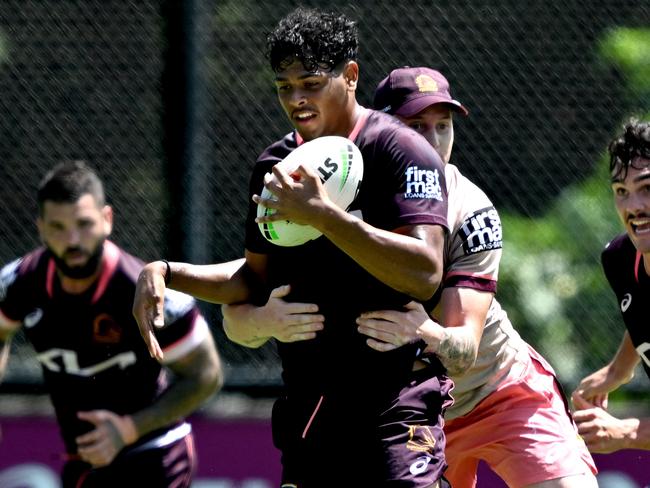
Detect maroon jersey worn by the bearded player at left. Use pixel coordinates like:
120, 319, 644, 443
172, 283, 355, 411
0, 241, 207, 454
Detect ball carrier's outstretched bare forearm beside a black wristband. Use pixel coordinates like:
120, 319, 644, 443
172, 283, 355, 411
165, 258, 250, 303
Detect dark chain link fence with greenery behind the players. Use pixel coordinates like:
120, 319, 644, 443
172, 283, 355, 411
0, 0, 650, 396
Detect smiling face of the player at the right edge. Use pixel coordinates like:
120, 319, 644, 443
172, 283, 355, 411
612, 158, 650, 253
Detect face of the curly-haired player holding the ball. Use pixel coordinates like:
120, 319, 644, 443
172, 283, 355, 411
275, 61, 358, 141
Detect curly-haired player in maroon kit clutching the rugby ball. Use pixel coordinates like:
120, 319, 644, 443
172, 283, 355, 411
135, 9, 451, 488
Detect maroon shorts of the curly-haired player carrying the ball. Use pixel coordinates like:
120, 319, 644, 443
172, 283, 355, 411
273, 369, 452, 488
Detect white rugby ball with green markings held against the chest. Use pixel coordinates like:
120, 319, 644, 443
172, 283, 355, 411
257, 136, 363, 247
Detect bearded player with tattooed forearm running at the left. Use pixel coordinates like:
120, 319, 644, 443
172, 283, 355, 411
0, 161, 223, 488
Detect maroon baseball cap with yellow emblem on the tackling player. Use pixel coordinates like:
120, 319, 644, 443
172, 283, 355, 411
373, 66, 469, 117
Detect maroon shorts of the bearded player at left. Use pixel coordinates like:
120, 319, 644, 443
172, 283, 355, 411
62, 426, 196, 488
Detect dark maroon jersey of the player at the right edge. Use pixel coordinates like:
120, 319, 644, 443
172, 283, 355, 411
601, 234, 650, 378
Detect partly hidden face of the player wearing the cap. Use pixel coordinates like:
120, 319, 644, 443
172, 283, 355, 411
398, 104, 454, 164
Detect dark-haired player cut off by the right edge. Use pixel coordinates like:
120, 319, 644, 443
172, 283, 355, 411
572, 119, 650, 453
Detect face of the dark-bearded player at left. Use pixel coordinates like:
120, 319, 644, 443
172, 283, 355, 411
37, 194, 113, 278
